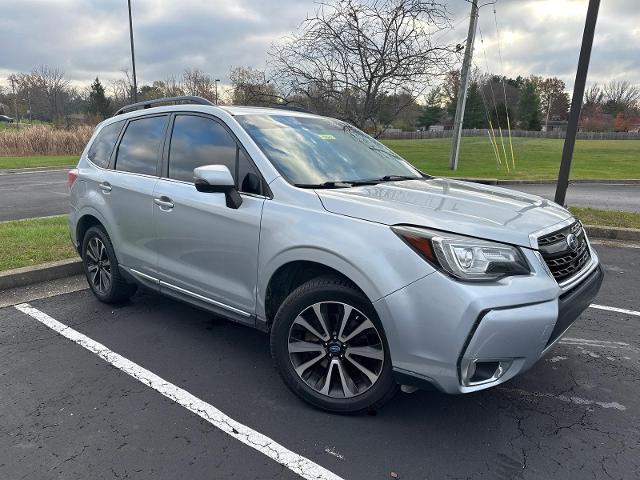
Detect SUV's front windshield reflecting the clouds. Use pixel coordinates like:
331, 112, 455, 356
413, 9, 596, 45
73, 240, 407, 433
236, 115, 422, 186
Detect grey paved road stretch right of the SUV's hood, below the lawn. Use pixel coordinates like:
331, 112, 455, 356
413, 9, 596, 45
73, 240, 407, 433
508, 183, 640, 212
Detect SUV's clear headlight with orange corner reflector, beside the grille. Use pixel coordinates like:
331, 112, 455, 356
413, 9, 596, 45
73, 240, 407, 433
391, 226, 531, 281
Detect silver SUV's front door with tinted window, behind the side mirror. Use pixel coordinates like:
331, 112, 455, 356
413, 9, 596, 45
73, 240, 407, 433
154, 114, 266, 322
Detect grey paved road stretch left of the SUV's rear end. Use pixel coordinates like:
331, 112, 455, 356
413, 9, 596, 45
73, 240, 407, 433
0, 170, 69, 221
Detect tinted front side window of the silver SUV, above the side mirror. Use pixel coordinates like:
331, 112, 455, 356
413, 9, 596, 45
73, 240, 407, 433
169, 115, 237, 182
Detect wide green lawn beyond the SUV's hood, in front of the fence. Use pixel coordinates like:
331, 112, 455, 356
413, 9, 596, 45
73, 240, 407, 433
383, 137, 640, 180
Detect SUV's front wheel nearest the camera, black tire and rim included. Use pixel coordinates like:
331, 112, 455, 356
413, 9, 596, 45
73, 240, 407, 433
271, 276, 397, 413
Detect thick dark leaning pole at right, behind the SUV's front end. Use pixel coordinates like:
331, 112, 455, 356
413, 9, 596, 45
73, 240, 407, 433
554, 0, 600, 205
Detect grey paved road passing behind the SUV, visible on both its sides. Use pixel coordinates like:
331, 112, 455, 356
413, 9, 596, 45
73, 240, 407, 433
0, 170, 640, 221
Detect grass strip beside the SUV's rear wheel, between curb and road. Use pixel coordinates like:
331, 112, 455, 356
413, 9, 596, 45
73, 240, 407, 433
0, 215, 78, 270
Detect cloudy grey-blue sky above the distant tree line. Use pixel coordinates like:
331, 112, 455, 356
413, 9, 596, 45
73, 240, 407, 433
0, 0, 640, 90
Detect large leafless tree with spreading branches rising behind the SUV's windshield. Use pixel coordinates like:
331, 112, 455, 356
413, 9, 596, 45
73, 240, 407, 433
270, 0, 455, 130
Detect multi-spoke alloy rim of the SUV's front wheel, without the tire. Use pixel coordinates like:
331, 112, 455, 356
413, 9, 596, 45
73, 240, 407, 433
288, 302, 385, 398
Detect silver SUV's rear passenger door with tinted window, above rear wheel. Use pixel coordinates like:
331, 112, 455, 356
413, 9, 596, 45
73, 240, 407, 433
99, 115, 169, 277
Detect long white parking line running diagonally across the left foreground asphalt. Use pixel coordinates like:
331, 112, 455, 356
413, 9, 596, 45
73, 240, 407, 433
15, 303, 342, 480
